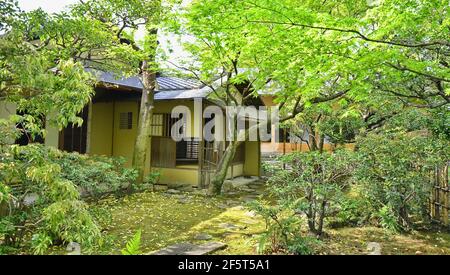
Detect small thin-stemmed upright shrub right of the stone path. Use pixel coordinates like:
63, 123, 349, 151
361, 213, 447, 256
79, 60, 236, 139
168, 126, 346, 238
268, 150, 355, 236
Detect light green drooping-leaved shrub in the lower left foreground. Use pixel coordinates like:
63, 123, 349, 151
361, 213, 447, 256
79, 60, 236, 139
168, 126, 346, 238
0, 144, 103, 254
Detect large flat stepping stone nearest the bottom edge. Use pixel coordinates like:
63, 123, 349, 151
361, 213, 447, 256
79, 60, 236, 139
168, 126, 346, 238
152, 242, 227, 255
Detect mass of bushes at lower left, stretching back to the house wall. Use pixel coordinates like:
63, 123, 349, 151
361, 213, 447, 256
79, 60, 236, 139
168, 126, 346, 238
0, 124, 136, 254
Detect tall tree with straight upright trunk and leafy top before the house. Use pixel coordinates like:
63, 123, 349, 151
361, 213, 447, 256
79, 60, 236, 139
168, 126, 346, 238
74, 0, 165, 185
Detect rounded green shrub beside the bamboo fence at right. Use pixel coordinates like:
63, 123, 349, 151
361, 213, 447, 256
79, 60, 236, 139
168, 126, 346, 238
356, 133, 450, 230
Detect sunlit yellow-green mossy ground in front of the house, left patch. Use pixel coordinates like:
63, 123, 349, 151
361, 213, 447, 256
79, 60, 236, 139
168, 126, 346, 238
93, 192, 264, 254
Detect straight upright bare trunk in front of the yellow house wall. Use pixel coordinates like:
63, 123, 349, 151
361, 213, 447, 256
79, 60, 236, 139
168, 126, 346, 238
133, 61, 156, 183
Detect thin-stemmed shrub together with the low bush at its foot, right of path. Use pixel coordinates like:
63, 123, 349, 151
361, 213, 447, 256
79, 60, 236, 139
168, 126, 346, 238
250, 150, 355, 254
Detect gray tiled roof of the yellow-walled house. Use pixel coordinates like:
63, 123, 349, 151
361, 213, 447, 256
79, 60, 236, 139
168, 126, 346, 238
87, 69, 211, 100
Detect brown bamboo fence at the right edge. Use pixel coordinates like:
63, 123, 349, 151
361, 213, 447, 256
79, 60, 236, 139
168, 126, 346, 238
431, 163, 450, 226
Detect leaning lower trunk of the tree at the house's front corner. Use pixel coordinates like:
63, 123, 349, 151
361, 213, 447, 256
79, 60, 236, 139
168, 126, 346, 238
208, 141, 242, 196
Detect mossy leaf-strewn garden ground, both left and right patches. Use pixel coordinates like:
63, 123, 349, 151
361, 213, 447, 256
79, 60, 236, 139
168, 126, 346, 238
89, 192, 450, 255
